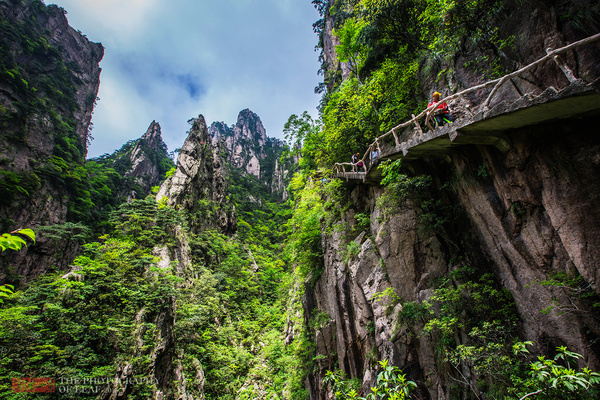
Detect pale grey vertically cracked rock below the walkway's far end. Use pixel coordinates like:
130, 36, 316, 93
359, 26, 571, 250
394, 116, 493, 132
304, 187, 447, 399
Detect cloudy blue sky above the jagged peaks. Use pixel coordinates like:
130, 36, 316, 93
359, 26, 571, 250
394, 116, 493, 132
46, 0, 320, 158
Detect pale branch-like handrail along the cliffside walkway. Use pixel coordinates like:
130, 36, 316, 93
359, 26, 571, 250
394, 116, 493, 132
334, 33, 600, 178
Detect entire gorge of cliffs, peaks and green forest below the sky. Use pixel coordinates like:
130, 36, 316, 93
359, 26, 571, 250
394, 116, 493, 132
0, 0, 600, 400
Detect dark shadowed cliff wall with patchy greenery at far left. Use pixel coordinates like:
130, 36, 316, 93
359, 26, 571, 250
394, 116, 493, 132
0, 0, 104, 282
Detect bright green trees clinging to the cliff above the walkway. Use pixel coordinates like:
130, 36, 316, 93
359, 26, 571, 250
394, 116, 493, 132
309, 0, 515, 166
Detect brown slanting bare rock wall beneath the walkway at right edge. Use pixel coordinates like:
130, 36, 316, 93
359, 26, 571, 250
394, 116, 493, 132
453, 120, 600, 356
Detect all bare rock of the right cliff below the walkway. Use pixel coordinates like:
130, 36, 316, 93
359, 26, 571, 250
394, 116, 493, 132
304, 114, 600, 399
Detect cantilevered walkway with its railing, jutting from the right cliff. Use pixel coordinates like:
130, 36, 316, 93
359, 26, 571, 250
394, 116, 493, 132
334, 34, 600, 182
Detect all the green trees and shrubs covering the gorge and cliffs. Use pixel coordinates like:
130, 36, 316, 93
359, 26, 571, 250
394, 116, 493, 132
0, 0, 600, 400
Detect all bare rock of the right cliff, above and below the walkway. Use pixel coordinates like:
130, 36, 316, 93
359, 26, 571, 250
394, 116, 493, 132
310, 1, 600, 399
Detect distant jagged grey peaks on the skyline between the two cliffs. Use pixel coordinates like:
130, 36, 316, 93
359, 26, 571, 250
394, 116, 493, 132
90, 109, 290, 211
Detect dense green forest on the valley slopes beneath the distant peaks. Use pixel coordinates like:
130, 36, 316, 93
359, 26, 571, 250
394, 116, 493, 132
0, 189, 310, 399
